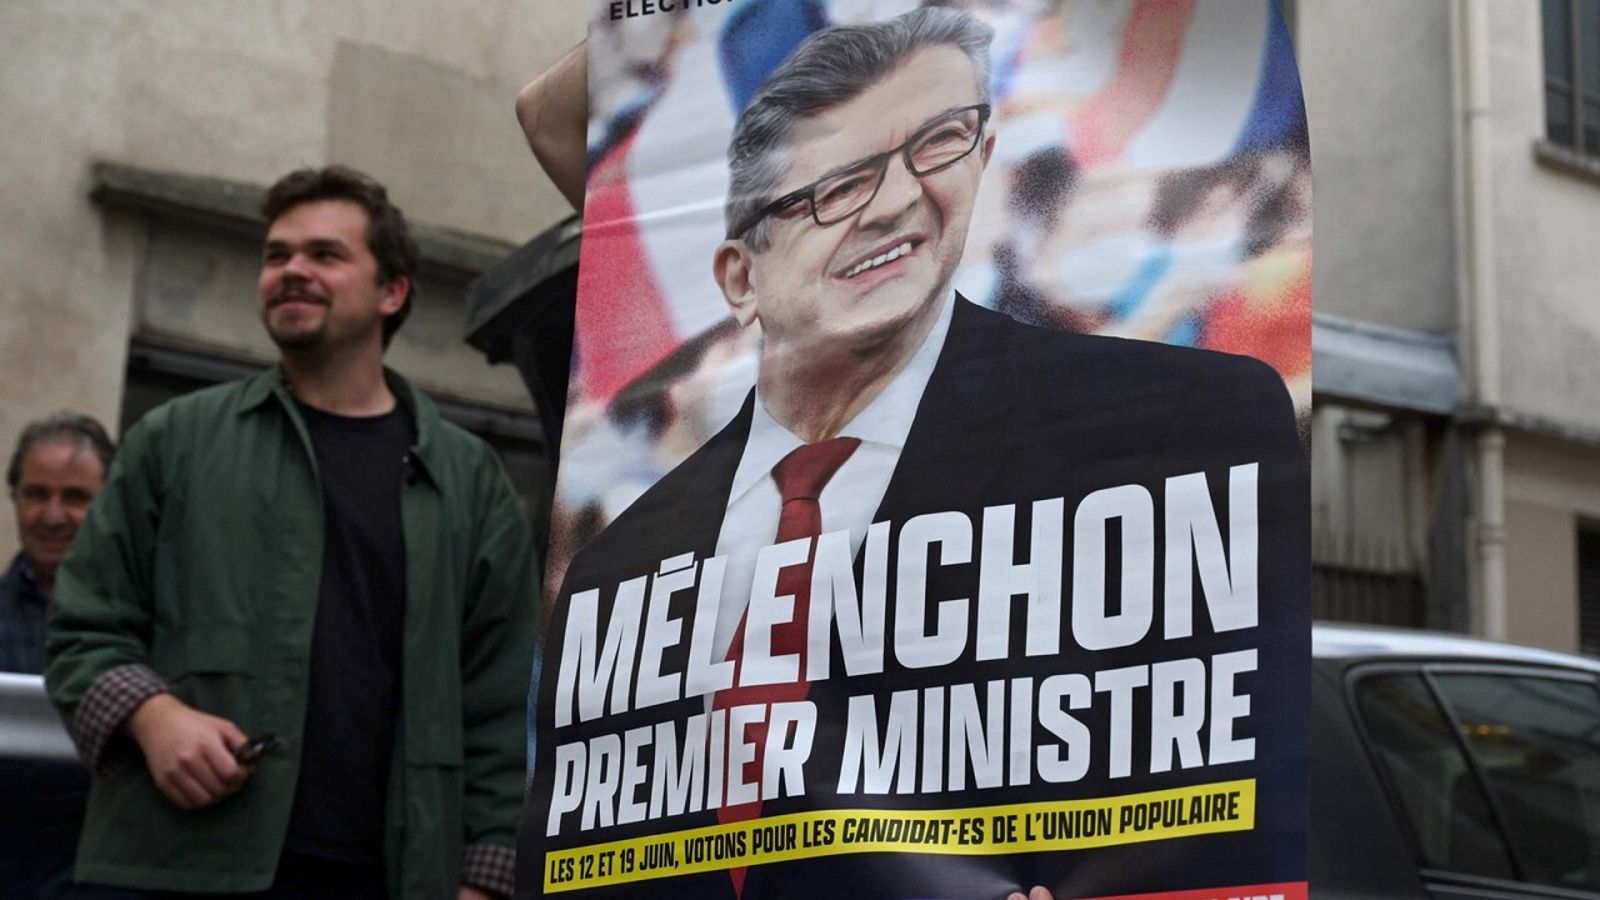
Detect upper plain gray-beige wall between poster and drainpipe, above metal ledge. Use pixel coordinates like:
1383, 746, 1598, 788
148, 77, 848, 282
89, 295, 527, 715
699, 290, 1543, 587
1294, 0, 1465, 333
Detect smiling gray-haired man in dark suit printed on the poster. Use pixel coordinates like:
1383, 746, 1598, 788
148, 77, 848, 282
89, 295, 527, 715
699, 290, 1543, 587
518, 8, 1309, 900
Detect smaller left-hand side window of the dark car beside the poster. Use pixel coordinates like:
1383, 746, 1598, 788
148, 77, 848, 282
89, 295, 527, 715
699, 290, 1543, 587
1355, 674, 1515, 878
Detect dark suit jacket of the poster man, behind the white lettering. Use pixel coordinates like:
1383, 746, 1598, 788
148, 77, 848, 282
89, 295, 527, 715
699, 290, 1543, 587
518, 299, 1310, 898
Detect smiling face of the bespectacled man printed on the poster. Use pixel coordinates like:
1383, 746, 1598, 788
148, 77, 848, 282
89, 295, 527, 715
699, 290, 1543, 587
736, 46, 992, 359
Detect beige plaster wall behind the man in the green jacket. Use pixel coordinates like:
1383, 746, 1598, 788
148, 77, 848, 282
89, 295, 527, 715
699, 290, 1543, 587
0, 0, 584, 551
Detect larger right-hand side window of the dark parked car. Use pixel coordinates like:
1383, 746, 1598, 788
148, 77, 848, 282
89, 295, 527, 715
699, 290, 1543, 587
1435, 674, 1600, 890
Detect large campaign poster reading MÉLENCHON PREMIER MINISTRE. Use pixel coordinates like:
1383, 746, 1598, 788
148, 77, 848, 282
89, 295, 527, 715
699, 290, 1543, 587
517, 0, 1312, 900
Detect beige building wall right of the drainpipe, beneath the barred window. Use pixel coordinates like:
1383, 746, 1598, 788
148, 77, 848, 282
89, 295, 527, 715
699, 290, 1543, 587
1488, 3, 1600, 652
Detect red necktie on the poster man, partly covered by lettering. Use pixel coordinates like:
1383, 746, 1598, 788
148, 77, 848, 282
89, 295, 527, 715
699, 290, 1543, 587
712, 437, 861, 895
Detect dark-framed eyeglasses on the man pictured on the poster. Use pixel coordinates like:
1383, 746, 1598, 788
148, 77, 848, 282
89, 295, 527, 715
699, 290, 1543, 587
733, 102, 989, 237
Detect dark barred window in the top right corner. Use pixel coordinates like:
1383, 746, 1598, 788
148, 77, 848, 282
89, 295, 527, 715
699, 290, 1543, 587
1542, 0, 1600, 157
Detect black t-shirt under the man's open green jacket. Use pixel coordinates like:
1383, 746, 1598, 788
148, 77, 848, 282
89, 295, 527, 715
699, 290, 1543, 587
288, 404, 414, 863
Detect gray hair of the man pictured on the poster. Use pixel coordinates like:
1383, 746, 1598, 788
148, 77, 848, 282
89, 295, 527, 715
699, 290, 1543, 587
723, 8, 994, 253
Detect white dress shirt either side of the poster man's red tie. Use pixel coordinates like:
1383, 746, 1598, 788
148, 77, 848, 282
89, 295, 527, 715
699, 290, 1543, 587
712, 290, 955, 660
